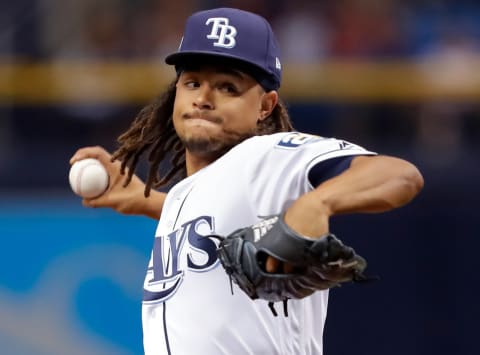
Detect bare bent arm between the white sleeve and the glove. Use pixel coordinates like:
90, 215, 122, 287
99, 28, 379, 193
285, 156, 423, 237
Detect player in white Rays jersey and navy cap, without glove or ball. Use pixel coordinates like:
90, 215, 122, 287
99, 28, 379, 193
71, 8, 423, 355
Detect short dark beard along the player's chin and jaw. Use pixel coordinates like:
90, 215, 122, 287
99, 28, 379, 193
180, 131, 255, 160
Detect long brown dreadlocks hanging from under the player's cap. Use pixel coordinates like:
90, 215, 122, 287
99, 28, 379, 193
112, 80, 293, 197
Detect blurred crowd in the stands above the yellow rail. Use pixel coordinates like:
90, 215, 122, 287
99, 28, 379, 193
0, 0, 480, 63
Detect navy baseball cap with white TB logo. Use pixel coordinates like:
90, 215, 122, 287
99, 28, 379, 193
165, 8, 282, 91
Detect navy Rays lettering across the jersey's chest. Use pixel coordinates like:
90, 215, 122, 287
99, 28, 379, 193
143, 216, 218, 303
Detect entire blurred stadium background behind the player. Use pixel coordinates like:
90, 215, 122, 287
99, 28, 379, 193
0, 0, 480, 355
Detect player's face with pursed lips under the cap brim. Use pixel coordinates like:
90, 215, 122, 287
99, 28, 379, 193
173, 67, 276, 158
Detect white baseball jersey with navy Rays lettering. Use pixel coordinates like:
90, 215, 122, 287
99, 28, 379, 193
142, 132, 374, 355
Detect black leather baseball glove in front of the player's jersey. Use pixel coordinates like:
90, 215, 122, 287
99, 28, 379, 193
211, 215, 367, 316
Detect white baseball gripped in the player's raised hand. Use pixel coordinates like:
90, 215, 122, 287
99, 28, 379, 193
68, 158, 108, 198
